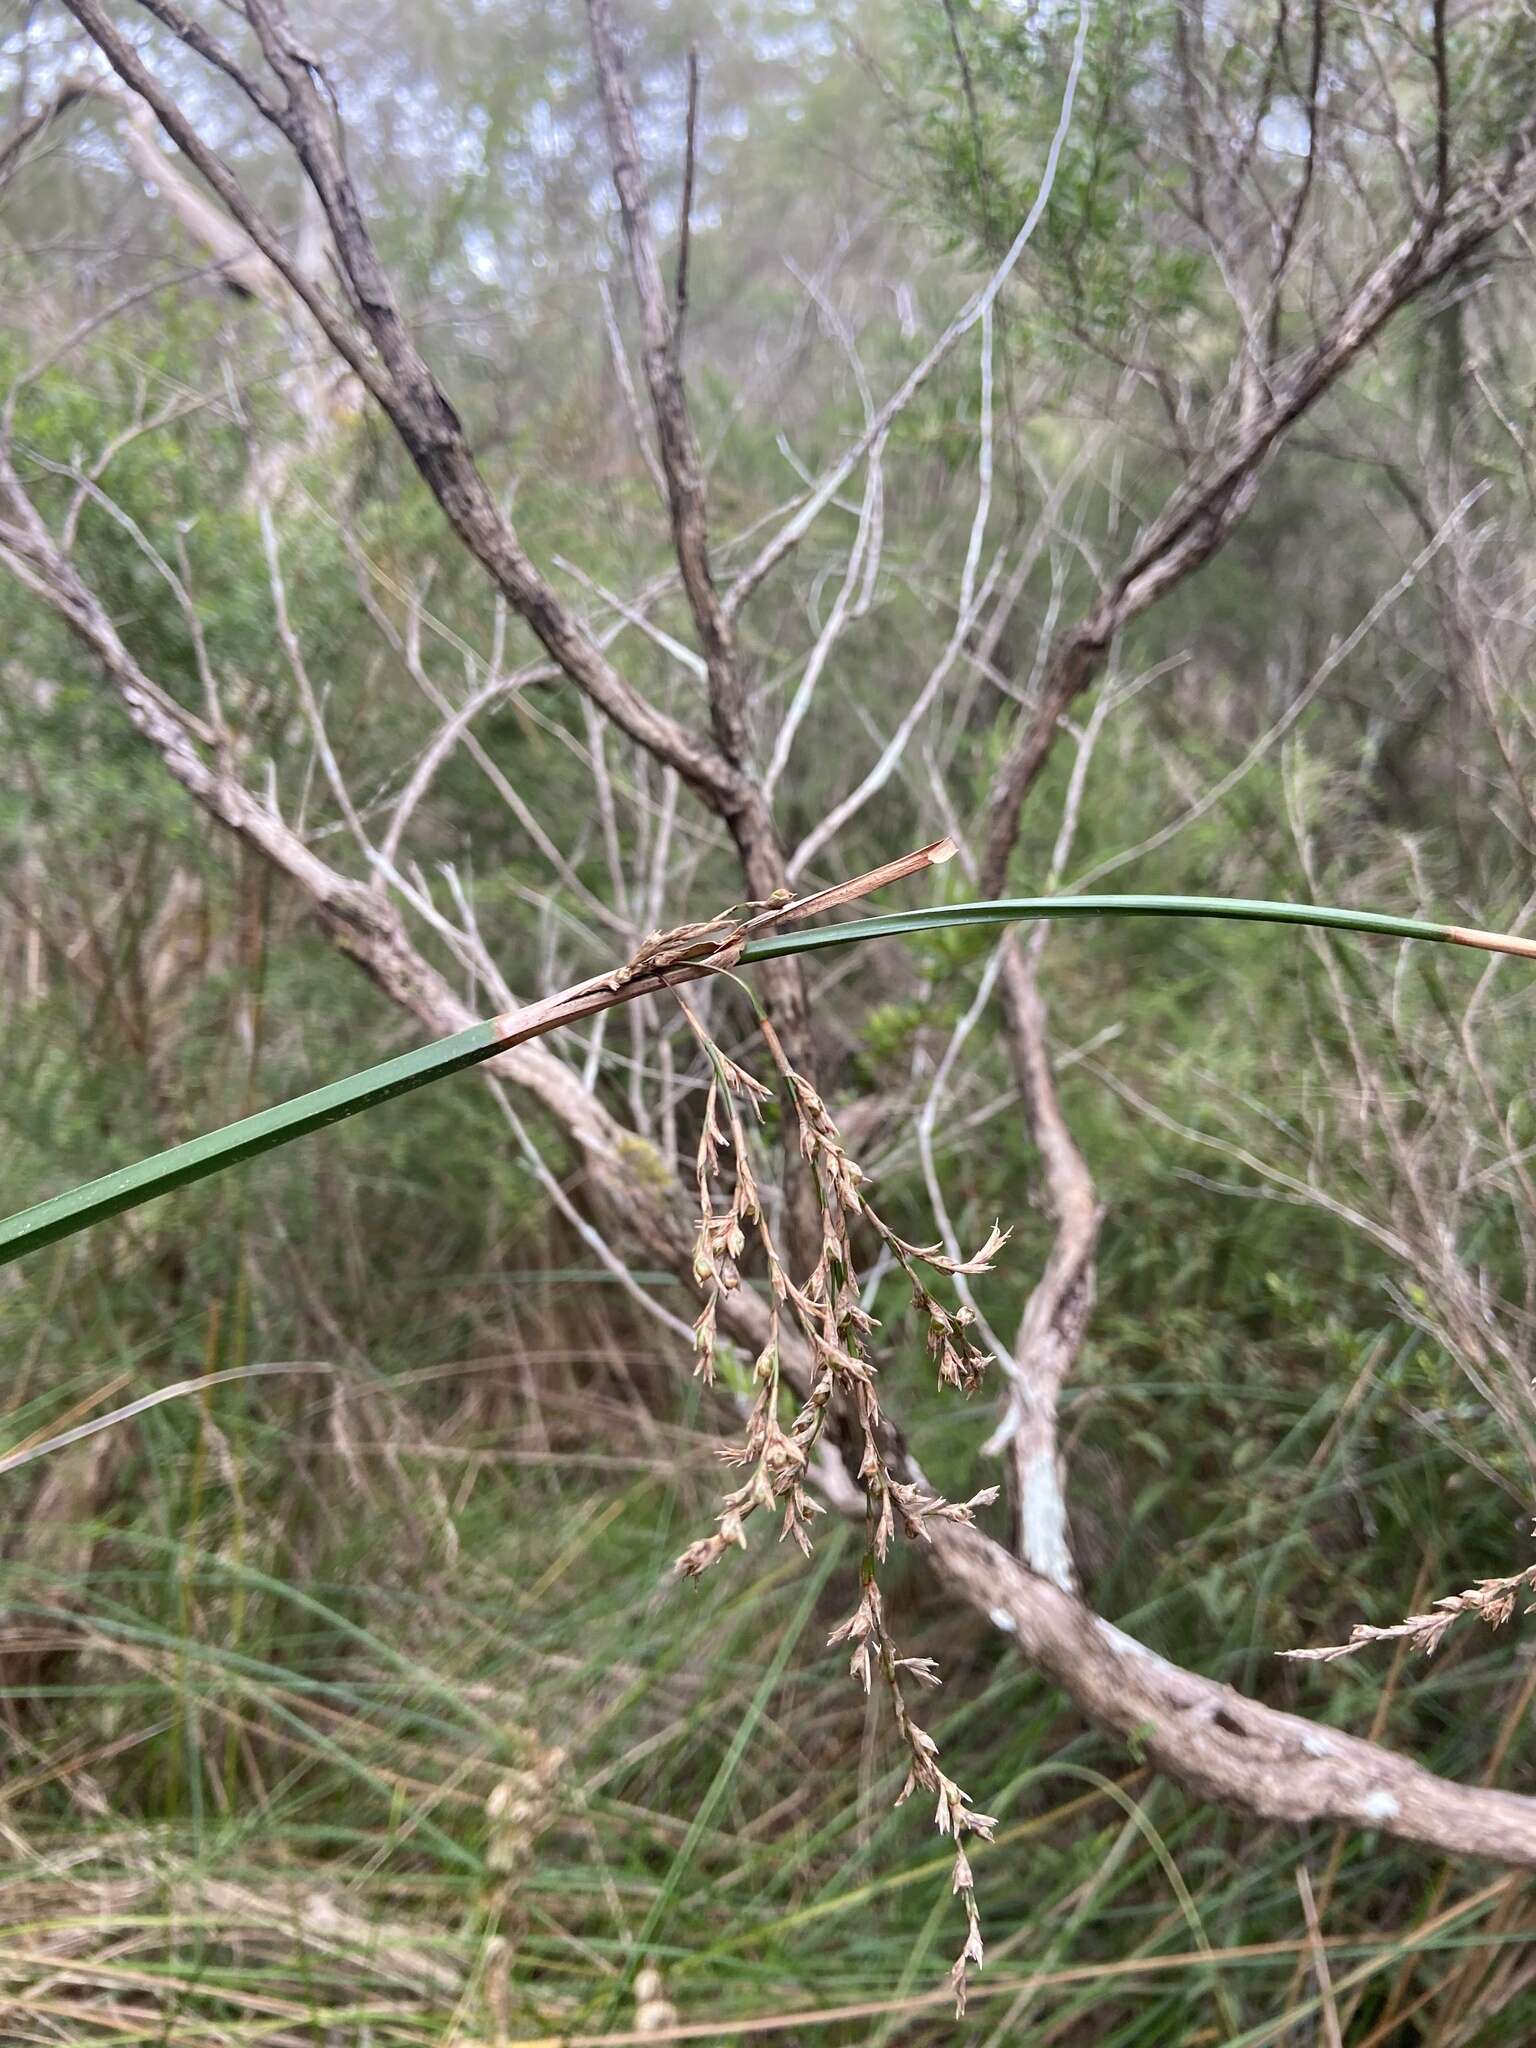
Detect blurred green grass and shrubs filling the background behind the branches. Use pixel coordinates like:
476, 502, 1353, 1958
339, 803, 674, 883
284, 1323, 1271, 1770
0, 0, 1536, 2048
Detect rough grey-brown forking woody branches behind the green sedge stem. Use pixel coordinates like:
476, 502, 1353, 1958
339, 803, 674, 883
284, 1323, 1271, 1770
0, 0, 1536, 1974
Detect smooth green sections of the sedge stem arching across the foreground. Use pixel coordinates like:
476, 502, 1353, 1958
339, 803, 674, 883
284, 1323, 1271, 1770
0, 895, 1536, 1266
